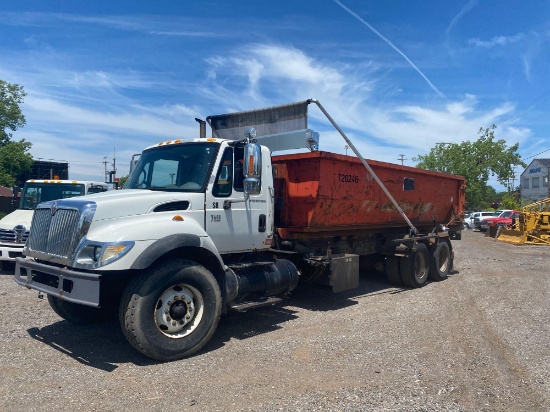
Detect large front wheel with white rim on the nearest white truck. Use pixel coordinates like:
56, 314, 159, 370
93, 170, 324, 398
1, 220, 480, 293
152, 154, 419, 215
119, 259, 222, 361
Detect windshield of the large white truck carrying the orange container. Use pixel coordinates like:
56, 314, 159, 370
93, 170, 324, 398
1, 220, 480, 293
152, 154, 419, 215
124, 142, 220, 192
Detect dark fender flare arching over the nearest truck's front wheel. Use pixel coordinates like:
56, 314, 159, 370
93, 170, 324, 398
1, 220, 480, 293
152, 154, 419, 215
130, 233, 224, 270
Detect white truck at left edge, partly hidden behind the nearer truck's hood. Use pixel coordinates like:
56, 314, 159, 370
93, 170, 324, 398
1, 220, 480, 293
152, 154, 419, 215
0, 179, 107, 263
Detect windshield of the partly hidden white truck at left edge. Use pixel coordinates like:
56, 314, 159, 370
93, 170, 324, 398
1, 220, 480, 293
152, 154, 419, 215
20, 182, 86, 210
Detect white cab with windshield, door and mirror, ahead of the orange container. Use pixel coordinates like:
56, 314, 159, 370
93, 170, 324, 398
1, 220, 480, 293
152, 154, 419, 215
124, 138, 273, 255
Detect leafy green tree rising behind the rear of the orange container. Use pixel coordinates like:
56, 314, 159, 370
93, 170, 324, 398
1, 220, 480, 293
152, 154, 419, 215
413, 125, 527, 209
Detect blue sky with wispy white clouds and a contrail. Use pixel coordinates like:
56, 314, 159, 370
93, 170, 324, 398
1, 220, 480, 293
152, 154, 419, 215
0, 0, 550, 189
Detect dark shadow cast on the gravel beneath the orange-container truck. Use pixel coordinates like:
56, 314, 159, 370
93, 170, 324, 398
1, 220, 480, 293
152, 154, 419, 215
27, 272, 457, 372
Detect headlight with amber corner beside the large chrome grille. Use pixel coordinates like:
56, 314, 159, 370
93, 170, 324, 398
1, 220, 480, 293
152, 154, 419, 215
75, 239, 134, 269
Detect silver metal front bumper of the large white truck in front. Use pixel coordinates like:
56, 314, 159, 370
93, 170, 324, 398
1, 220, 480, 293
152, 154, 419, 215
14, 257, 101, 307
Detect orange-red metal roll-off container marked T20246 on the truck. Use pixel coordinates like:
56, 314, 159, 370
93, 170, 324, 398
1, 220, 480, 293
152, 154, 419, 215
273, 151, 465, 237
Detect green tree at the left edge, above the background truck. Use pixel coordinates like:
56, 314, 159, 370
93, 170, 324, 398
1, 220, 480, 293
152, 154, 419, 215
0, 80, 32, 187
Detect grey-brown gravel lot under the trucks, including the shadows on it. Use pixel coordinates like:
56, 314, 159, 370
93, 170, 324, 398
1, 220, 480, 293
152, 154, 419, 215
0, 231, 550, 411
